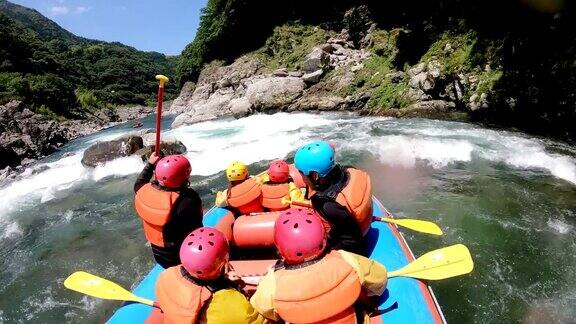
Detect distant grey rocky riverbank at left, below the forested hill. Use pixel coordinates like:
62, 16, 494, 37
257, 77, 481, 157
0, 101, 171, 181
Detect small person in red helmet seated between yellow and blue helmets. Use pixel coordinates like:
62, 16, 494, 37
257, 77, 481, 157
262, 160, 304, 211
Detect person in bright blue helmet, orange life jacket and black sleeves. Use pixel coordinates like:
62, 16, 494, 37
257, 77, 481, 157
294, 141, 372, 254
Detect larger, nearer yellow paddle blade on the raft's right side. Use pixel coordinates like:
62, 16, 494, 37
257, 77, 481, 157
388, 244, 474, 280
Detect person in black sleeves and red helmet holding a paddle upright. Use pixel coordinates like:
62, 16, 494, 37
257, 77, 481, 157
134, 153, 203, 268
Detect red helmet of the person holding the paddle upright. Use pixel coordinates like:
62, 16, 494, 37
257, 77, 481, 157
155, 155, 192, 189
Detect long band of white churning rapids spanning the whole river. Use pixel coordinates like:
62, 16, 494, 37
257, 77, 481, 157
0, 113, 576, 238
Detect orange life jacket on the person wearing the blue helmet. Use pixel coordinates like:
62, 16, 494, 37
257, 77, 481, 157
321, 168, 372, 235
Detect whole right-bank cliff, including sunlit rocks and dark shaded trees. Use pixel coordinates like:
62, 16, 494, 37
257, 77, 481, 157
175, 0, 576, 140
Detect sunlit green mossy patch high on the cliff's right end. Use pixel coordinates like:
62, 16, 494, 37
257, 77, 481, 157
420, 31, 478, 74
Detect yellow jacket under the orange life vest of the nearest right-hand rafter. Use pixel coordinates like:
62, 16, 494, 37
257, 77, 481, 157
250, 250, 388, 323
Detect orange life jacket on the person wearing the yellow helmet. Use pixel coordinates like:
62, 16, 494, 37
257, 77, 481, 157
228, 178, 264, 215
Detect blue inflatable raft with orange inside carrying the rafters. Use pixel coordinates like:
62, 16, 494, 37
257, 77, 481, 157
108, 197, 446, 324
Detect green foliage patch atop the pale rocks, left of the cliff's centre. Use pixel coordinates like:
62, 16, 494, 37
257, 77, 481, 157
257, 23, 332, 69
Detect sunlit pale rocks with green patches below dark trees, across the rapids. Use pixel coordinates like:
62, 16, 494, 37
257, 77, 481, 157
172, 6, 492, 127
